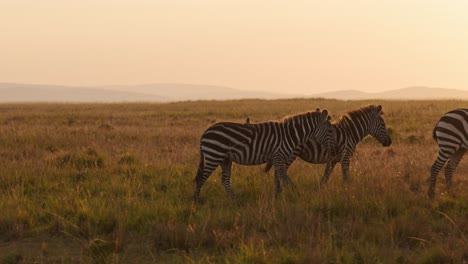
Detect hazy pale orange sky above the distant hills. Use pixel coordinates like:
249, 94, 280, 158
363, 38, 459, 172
0, 0, 468, 94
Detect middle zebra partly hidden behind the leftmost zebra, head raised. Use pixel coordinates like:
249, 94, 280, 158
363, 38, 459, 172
265, 105, 392, 186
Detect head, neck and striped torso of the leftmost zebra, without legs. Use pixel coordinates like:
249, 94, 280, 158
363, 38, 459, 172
200, 110, 333, 165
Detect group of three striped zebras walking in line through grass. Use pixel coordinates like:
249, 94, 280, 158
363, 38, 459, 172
193, 105, 468, 201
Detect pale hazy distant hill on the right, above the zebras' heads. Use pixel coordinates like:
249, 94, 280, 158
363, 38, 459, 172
313, 86, 468, 100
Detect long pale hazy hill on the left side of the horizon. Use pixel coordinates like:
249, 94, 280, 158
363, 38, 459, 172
0, 83, 294, 102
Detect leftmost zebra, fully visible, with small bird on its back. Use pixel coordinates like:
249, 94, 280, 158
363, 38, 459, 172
193, 110, 333, 201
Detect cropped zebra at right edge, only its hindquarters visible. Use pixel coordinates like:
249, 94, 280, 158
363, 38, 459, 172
427, 108, 468, 199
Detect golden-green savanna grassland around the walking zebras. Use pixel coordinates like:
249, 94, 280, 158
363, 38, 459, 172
0, 99, 468, 263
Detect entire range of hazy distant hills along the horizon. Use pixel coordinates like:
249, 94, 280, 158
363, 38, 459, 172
0, 83, 468, 103
